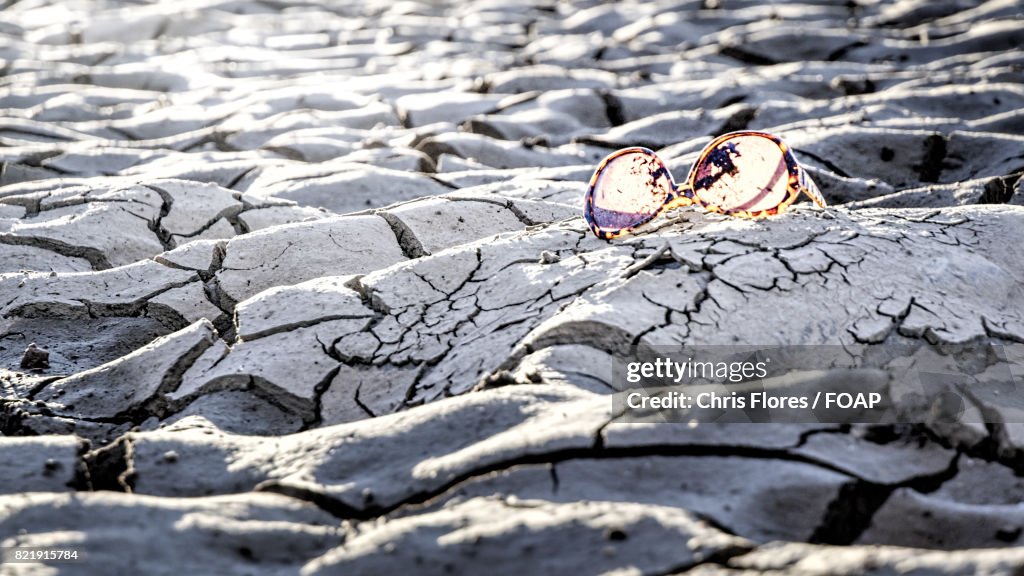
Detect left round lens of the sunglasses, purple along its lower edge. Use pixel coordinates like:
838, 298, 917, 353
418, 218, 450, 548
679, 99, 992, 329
591, 151, 673, 232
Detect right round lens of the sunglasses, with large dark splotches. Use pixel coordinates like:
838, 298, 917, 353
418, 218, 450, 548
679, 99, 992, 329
693, 135, 790, 212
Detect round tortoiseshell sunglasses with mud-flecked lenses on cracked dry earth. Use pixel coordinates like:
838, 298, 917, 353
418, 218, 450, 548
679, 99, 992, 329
584, 131, 825, 240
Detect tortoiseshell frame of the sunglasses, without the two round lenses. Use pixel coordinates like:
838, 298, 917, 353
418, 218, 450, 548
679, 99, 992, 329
583, 130, 827, 240
